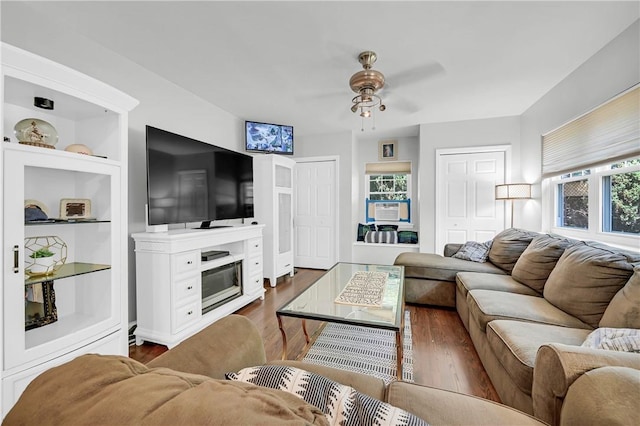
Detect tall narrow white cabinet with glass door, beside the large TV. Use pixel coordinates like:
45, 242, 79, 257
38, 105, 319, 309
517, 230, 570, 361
253, 154, 296, 287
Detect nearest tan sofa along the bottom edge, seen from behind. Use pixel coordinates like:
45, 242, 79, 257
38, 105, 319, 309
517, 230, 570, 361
3, 315, 635, 426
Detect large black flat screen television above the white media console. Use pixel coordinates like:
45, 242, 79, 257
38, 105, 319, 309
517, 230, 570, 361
146, 126, 253, 228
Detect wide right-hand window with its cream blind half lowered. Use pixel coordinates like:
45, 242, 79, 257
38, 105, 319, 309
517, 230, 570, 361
542, 85, 640, 244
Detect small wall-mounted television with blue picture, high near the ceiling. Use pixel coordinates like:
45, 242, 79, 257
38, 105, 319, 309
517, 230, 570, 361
244, 121, 293, 155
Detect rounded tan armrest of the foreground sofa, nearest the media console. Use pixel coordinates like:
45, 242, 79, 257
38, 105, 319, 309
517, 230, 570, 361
147, 315, 267, 379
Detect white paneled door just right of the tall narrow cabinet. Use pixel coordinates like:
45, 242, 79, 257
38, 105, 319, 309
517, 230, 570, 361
293, 160, 338, 269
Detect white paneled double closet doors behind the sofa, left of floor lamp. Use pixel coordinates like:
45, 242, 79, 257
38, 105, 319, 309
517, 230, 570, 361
435, 150, 506, 252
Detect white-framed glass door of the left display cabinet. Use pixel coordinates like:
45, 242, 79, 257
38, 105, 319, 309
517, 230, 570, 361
3, 146, 121, 370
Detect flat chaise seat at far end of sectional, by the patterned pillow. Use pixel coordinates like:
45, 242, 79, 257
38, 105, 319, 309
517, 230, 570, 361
394, 252, 504, 282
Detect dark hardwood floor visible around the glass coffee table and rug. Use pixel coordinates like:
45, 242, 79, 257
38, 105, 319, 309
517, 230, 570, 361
129, 269, 500, 401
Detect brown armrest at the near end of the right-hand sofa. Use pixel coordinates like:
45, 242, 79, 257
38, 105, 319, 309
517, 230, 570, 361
532, 343, 640, 425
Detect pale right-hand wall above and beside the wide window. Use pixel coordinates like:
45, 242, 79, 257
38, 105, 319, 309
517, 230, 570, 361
517, 21, 640, 232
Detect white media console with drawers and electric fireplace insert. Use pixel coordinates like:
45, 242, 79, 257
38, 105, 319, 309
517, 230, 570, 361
132, 225, 264, 348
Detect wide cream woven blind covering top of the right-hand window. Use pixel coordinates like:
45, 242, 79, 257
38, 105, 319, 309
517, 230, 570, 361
542, 85, 640, 178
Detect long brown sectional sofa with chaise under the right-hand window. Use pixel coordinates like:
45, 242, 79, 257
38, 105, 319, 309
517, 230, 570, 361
395, 229, 640, 424
